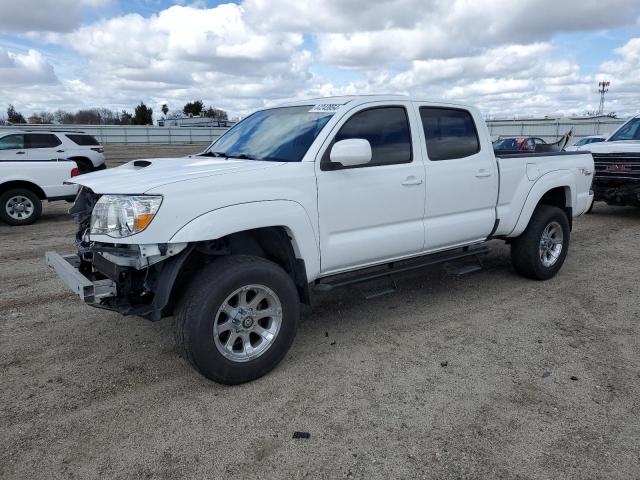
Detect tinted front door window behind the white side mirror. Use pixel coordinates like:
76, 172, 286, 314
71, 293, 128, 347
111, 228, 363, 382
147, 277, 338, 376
325, 107, 411, 167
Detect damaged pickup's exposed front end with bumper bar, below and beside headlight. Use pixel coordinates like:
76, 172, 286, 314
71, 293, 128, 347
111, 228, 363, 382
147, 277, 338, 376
46, 188, 192, 321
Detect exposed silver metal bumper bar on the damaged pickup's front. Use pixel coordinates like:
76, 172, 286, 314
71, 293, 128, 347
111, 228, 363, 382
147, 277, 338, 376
46, 252, 118, 303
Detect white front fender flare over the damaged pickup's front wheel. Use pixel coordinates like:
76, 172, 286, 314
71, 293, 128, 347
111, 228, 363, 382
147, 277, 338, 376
169, 200, 320, 282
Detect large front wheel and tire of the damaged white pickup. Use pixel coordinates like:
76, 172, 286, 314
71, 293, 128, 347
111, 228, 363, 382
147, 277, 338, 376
176, 255, 300, 385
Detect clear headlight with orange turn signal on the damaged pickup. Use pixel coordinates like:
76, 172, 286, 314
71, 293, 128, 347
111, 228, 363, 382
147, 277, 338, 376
91, 195, 162, 238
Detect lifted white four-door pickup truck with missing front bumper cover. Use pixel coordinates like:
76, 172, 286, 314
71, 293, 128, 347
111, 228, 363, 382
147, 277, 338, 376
47, 96, 594, 384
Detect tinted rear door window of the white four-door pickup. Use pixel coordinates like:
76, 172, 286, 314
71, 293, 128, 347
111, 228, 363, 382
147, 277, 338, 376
420, 107, 480, 160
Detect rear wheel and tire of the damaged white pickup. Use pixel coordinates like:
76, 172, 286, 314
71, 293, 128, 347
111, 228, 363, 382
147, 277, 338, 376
511, 205, 570, 280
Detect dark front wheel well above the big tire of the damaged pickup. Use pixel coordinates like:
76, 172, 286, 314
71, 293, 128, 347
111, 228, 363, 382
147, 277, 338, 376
172, 227, 309, 304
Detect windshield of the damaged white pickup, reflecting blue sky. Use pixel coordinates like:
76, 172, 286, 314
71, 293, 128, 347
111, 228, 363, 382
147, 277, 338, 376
204, 105, 334, 162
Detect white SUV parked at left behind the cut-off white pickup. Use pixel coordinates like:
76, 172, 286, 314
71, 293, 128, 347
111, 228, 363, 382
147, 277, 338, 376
0, 130, 106, 174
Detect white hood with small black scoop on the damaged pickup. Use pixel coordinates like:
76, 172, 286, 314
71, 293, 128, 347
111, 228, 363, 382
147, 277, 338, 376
66, 156, 283, 194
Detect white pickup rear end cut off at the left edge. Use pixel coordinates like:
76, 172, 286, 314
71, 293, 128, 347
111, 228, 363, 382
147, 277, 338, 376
0, 158, 79, 226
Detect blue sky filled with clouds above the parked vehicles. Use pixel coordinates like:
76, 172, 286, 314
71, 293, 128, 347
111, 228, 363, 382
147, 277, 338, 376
0, 0, 640, 117
